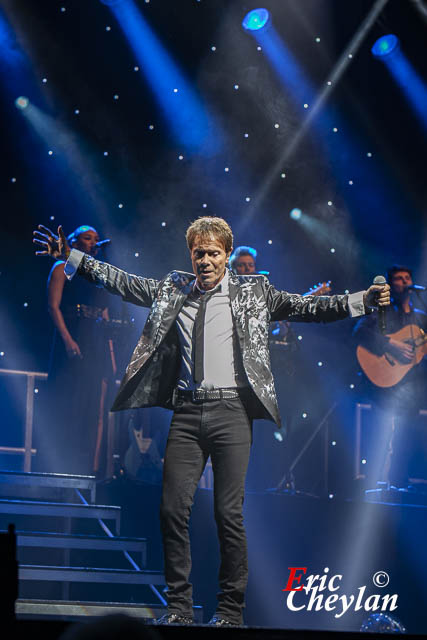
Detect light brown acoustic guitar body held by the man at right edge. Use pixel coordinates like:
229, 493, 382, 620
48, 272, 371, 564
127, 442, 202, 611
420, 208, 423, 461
356, 324, 427, 388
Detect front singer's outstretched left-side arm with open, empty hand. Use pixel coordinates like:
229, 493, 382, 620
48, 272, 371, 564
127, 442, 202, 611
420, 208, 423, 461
33, 225, 158, 307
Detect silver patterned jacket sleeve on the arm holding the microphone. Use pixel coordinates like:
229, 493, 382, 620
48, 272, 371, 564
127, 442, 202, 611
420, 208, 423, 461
265, 279, 365, 322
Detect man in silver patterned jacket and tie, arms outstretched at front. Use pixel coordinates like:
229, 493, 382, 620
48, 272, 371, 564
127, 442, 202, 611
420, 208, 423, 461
34, 217, 390, 627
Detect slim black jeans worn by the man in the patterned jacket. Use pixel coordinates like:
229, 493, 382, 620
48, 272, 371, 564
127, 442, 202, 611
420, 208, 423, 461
160, 398, 252, 624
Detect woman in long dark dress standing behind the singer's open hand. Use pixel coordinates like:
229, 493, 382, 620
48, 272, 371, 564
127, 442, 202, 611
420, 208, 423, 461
37, 225, 112, 474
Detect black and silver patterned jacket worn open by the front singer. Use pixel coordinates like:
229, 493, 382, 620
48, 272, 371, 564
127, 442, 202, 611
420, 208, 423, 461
78, 255, 349, 426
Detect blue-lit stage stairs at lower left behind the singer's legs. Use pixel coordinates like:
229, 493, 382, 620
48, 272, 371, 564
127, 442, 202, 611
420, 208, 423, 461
0, 470, 203, 622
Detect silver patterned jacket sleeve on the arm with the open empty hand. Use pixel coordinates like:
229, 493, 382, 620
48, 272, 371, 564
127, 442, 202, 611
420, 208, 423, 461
64, 249, 159, 307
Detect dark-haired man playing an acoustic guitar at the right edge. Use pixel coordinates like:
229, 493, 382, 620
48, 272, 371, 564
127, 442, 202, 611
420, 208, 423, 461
353, 265, 427, 487
